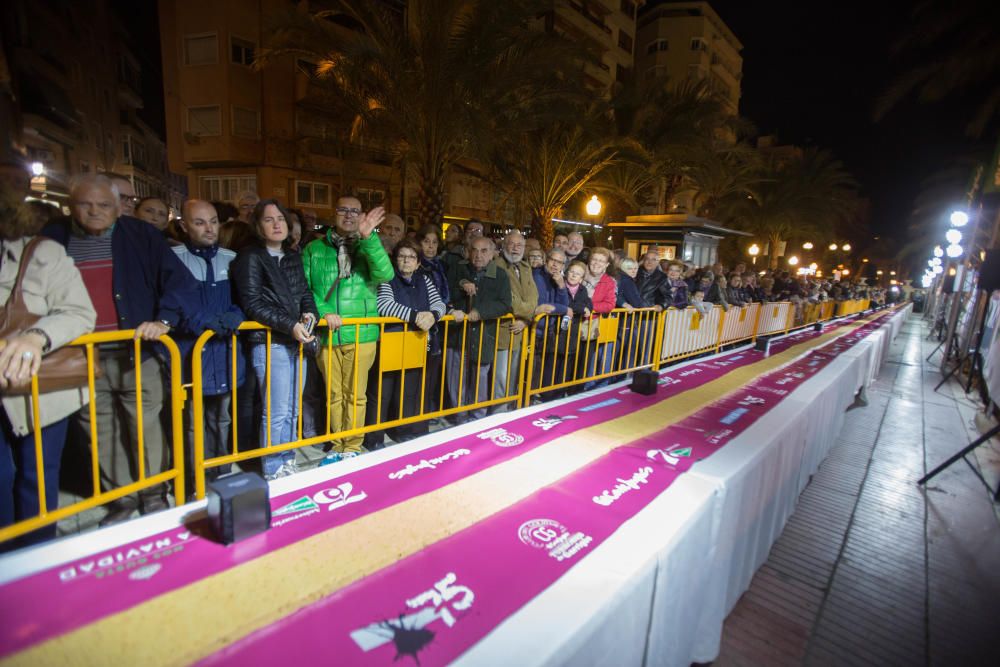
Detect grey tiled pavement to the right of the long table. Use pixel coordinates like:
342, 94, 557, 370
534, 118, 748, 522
714, 314, 1000, 667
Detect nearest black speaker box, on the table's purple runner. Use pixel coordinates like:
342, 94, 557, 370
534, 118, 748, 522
205, 472, 271, 544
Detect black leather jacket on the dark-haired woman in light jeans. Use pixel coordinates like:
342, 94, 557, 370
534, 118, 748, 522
229, 244, 319, 345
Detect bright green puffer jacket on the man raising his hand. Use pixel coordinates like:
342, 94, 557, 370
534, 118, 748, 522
302, 229, 394, 345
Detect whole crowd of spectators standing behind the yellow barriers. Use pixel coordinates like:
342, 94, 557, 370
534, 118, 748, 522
0, 175, 885, 548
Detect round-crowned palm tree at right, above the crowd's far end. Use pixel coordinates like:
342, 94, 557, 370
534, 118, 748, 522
720, 148, 857, 268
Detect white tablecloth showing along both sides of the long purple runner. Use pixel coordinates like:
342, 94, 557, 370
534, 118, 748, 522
0, 306, 910, 666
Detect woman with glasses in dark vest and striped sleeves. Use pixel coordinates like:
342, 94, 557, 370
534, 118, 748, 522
367, 239, 446, 448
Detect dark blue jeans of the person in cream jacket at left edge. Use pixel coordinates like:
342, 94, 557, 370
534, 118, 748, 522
0, 408, 69, 552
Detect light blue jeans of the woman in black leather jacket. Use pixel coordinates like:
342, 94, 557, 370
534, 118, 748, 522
251, 343, 306, 476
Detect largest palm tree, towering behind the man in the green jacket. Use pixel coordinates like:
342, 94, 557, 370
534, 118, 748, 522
260, 0, 582, 223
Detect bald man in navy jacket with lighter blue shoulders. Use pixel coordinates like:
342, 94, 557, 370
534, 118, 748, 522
173, 199, 246, 492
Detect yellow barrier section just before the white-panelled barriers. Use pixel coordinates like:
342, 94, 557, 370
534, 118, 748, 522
524, 308, 662, 400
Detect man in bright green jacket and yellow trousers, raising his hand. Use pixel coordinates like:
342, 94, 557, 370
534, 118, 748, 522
302, 197, 393, 456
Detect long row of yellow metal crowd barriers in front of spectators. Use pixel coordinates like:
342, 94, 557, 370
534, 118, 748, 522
0, 300, 869, 542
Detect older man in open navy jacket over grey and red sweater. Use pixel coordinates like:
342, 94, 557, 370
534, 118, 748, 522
42, 174, 197, 525
